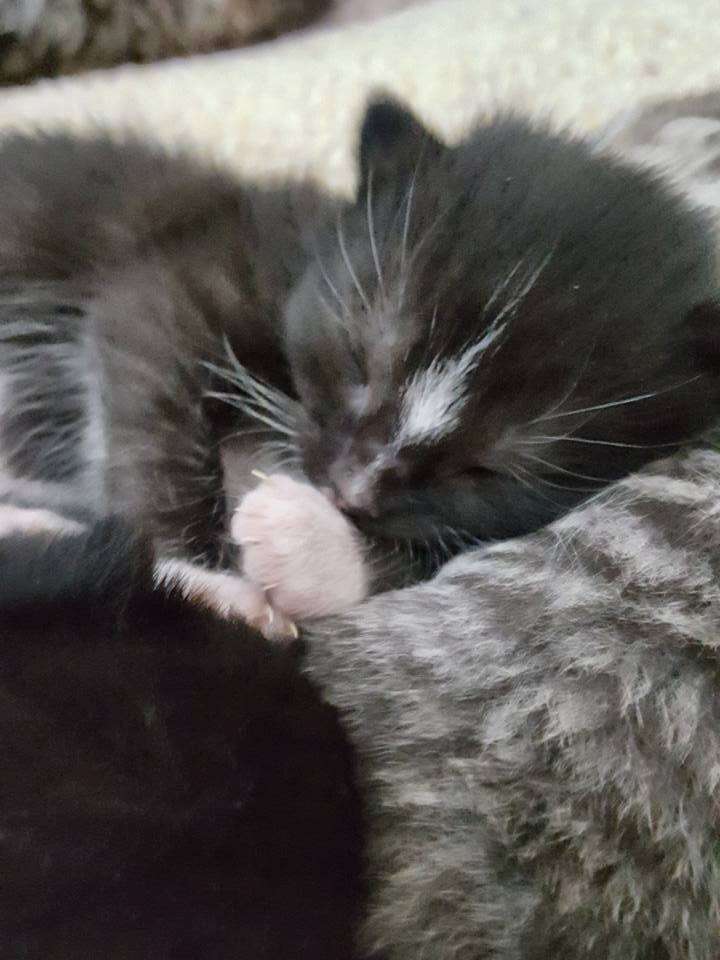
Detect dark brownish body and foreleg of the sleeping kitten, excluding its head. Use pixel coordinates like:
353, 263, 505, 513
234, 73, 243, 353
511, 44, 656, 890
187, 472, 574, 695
0, 131, 334, 562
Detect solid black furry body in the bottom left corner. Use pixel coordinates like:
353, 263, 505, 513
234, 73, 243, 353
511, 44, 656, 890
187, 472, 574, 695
0, 505, 362, 960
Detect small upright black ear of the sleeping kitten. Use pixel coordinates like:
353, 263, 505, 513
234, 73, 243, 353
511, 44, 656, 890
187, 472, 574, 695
359, 96, 444, 194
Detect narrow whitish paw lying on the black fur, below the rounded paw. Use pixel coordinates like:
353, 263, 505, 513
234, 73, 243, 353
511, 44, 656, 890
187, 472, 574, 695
155, 560, 299, 640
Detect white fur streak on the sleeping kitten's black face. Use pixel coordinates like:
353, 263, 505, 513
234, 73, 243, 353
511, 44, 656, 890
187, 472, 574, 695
396, 323, 505, 445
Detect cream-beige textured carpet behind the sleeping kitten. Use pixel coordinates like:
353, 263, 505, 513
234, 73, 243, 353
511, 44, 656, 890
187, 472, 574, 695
0, 0, 720, 193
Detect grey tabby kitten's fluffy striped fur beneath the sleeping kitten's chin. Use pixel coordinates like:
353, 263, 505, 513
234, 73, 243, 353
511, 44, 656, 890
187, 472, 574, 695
309, 452, 720, 960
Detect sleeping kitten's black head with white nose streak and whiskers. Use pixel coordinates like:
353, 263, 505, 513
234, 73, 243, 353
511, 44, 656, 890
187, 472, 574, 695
287, 100, 720, 541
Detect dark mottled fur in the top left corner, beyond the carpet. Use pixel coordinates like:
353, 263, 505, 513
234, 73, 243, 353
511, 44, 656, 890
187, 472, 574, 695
0, 0, 330, 83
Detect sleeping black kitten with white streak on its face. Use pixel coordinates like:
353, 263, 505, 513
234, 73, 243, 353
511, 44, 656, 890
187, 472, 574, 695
0, 101, 720, 624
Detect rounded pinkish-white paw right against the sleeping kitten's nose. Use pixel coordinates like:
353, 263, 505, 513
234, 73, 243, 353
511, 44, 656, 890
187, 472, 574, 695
231, 475, 368, 620
